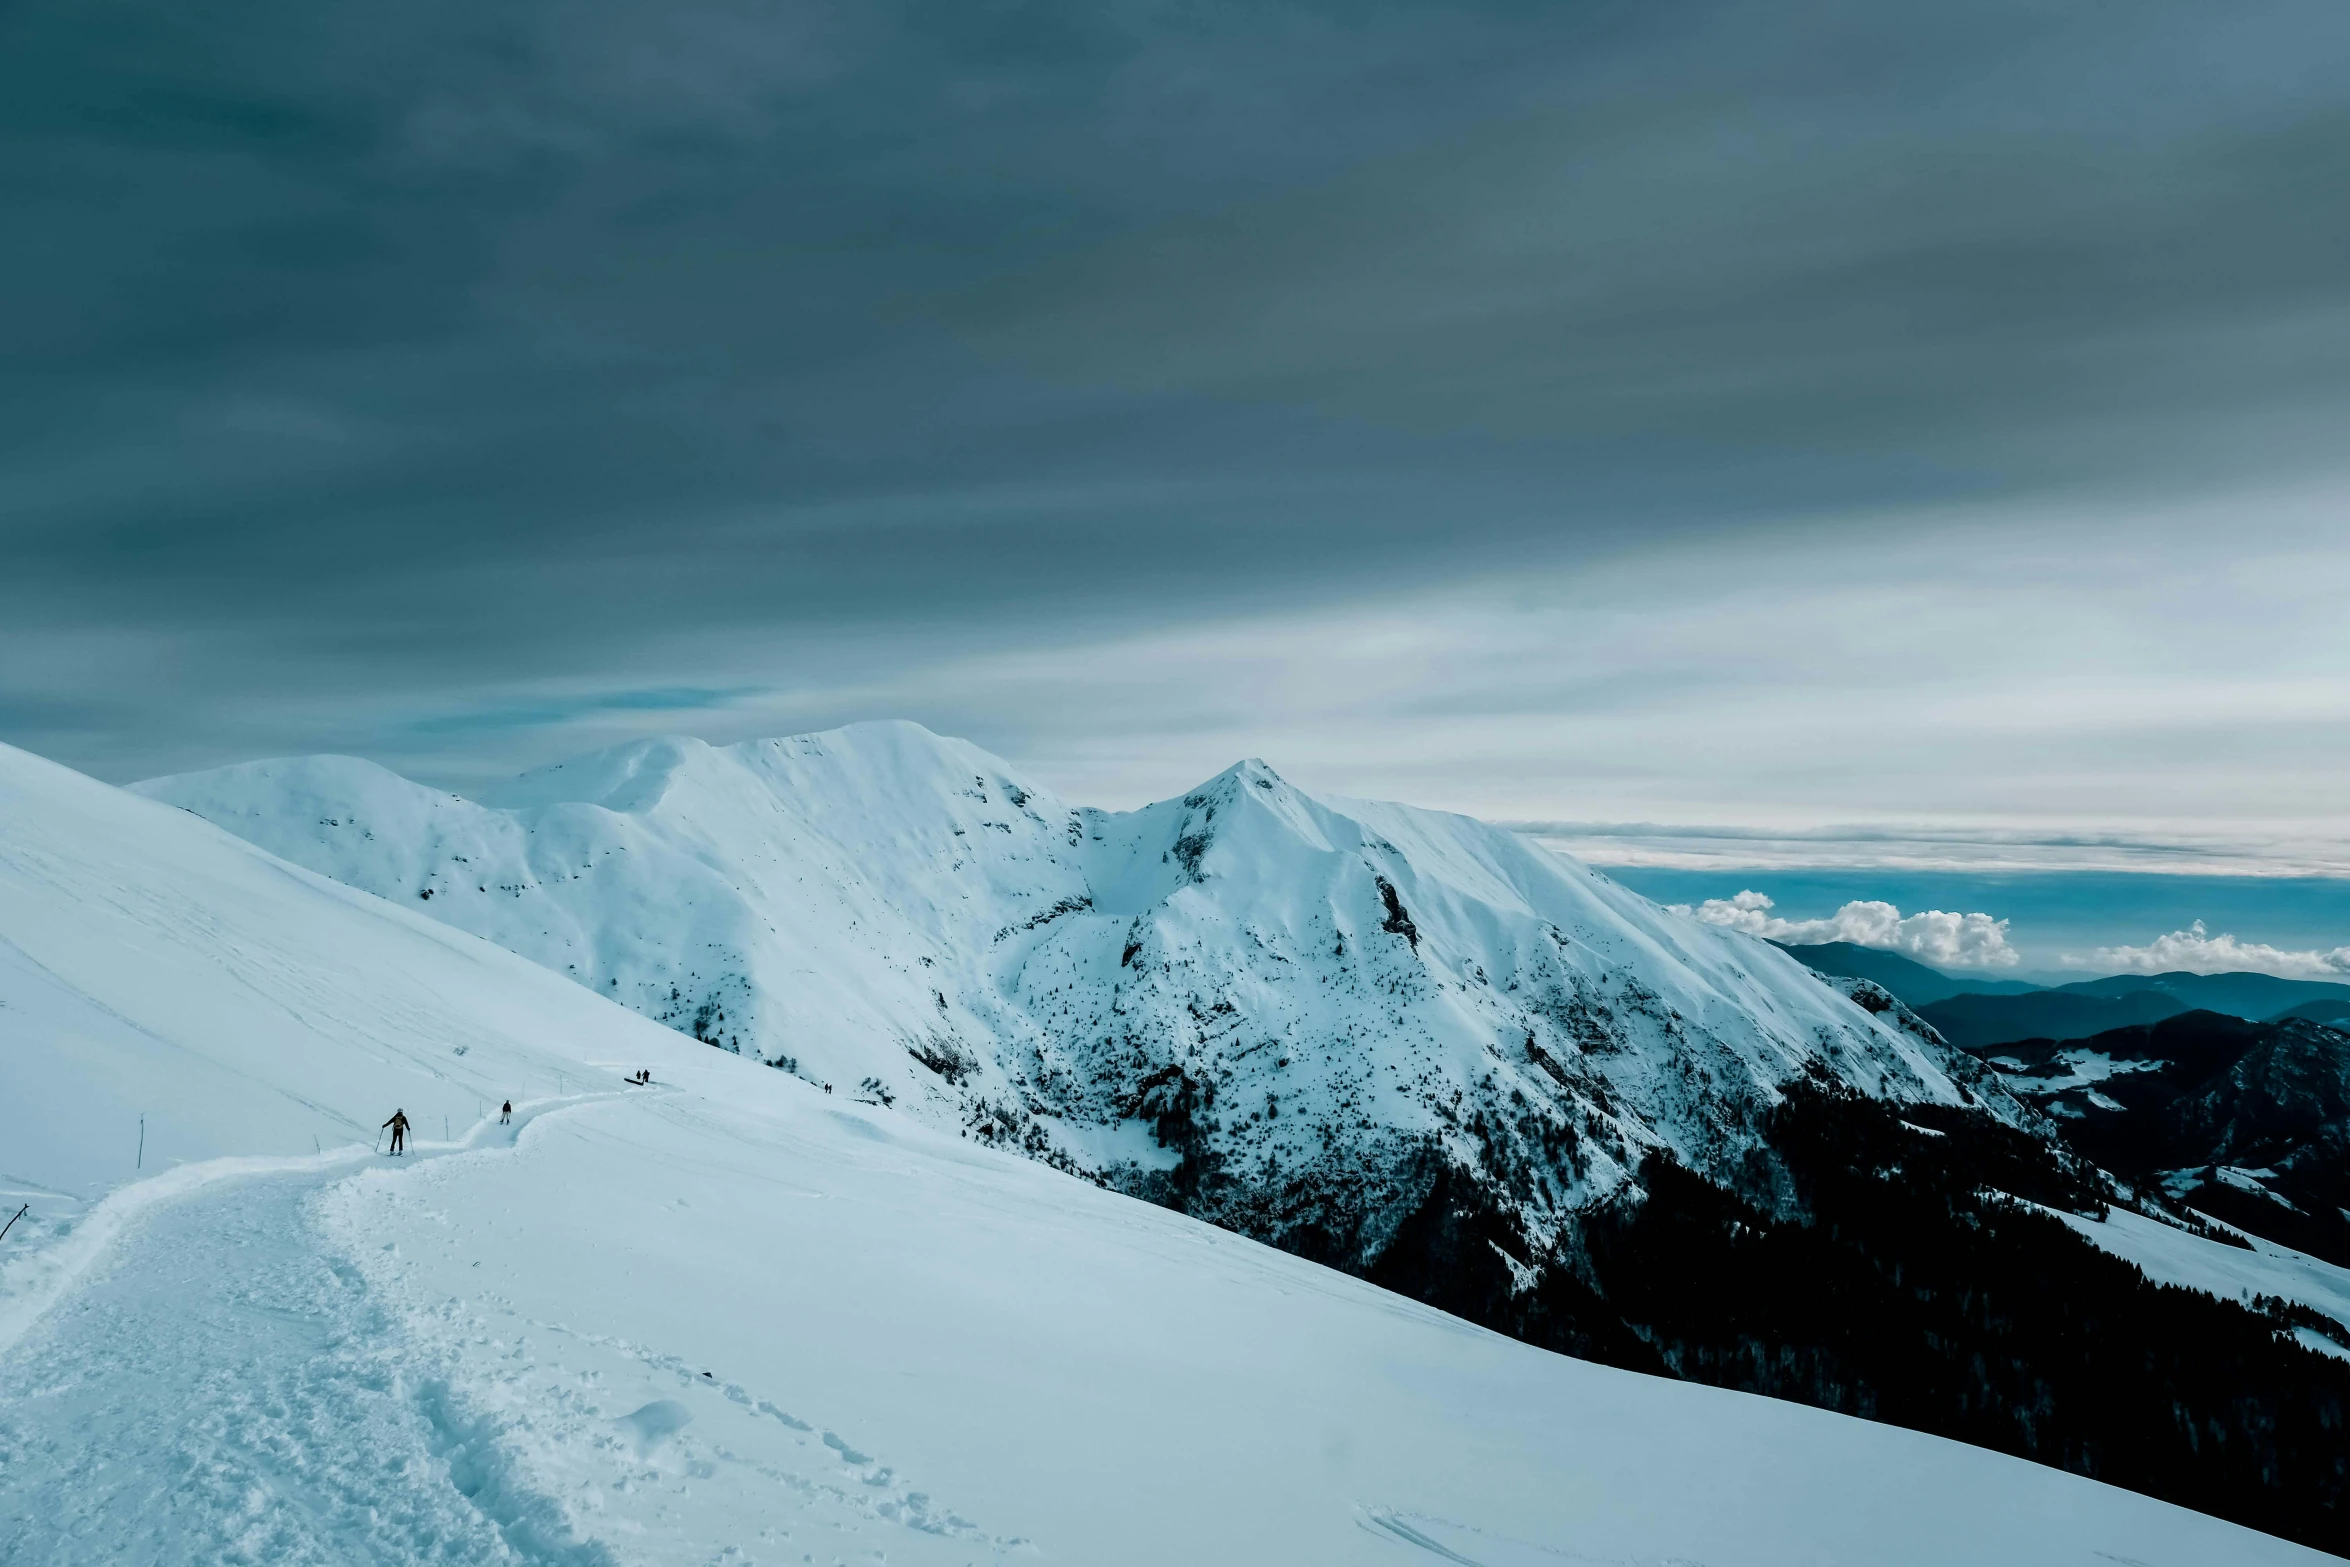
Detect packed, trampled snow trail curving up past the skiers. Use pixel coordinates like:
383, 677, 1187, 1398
0, 1107, 613, 1567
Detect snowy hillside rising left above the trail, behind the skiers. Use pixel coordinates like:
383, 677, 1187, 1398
0, 732, 712, 1339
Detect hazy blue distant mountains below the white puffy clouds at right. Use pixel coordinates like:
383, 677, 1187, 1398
1788, 942, 2350, 1050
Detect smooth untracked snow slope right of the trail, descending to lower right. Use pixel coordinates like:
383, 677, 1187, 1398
331, 1090, 2322, 1567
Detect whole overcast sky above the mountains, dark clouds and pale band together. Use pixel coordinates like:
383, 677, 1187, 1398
0, 0, 2350, 920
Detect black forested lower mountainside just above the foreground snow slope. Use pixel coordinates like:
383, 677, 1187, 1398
1361, 1085, 2350, 1553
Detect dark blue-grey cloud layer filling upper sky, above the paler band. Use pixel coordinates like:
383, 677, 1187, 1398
0, 0, 2350, 775
